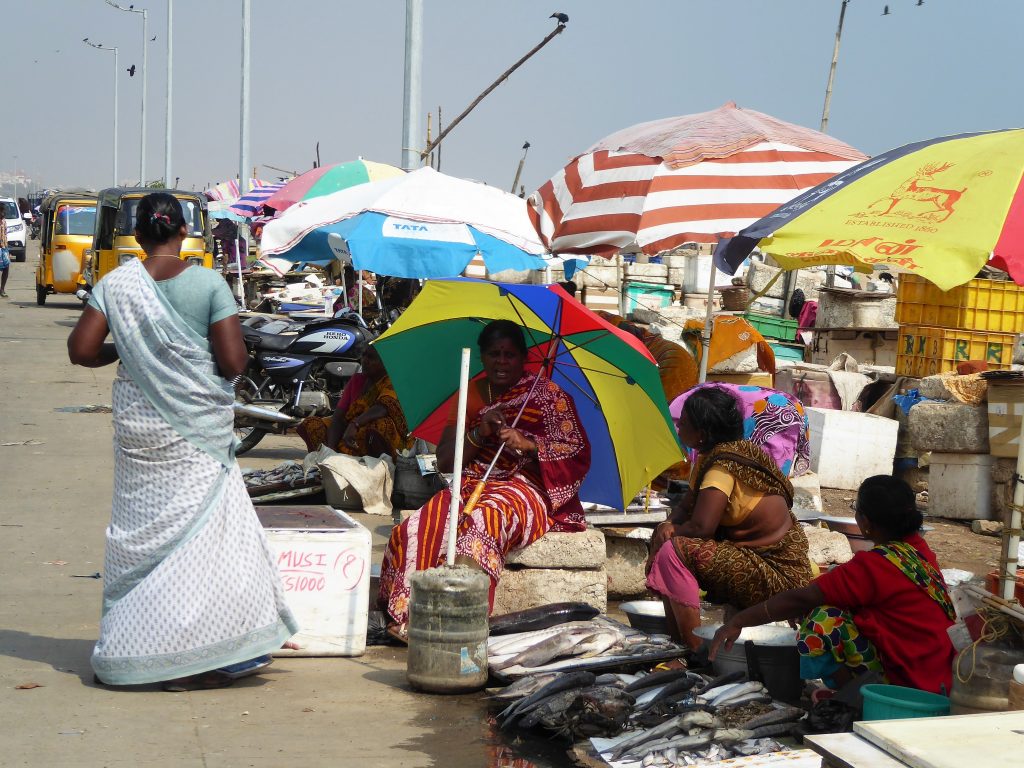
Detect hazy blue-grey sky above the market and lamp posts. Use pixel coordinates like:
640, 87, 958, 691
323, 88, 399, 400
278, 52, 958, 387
0, 0, 1024, 198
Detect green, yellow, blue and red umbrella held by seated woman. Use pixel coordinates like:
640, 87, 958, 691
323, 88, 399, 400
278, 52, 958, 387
374, 280, 682, 509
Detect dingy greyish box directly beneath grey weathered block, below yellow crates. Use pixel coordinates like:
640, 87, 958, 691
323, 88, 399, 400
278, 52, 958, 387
928, 452, 995, 520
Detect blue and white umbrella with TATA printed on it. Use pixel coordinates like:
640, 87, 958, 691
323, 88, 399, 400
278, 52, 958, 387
261, 168, 565, 279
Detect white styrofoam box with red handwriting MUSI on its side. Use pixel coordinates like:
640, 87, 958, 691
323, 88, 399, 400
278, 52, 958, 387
256, 505, 371, 656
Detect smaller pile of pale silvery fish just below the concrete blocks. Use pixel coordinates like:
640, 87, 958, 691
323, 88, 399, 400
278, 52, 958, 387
487, 616, 686, 679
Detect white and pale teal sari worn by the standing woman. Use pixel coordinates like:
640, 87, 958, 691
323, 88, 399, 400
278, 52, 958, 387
92, 261, 298, 685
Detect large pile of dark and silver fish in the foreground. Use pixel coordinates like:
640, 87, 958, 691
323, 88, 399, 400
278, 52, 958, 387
494, 669, 804, 768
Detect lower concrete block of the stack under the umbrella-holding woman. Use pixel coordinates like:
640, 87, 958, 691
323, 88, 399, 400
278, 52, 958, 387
493, 568, 608, 615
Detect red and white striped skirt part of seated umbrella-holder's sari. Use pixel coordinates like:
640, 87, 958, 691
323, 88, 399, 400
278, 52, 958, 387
379, 476, 551, 624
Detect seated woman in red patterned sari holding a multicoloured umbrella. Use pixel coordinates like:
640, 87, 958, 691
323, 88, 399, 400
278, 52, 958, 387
379, 321, 590, 637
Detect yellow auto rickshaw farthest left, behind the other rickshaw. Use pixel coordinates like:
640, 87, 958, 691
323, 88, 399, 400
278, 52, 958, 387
36, 191, 96, 306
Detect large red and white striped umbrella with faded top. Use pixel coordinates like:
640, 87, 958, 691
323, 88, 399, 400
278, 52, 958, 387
529, 102, 866, 256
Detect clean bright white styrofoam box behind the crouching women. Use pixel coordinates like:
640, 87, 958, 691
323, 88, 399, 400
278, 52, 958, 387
805, 408, 899, 490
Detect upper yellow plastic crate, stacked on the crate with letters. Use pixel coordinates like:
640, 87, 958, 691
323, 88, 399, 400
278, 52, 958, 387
896, 274, 1024, 333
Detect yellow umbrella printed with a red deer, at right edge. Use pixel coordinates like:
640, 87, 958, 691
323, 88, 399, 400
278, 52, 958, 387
715, 128, 1024, 291
